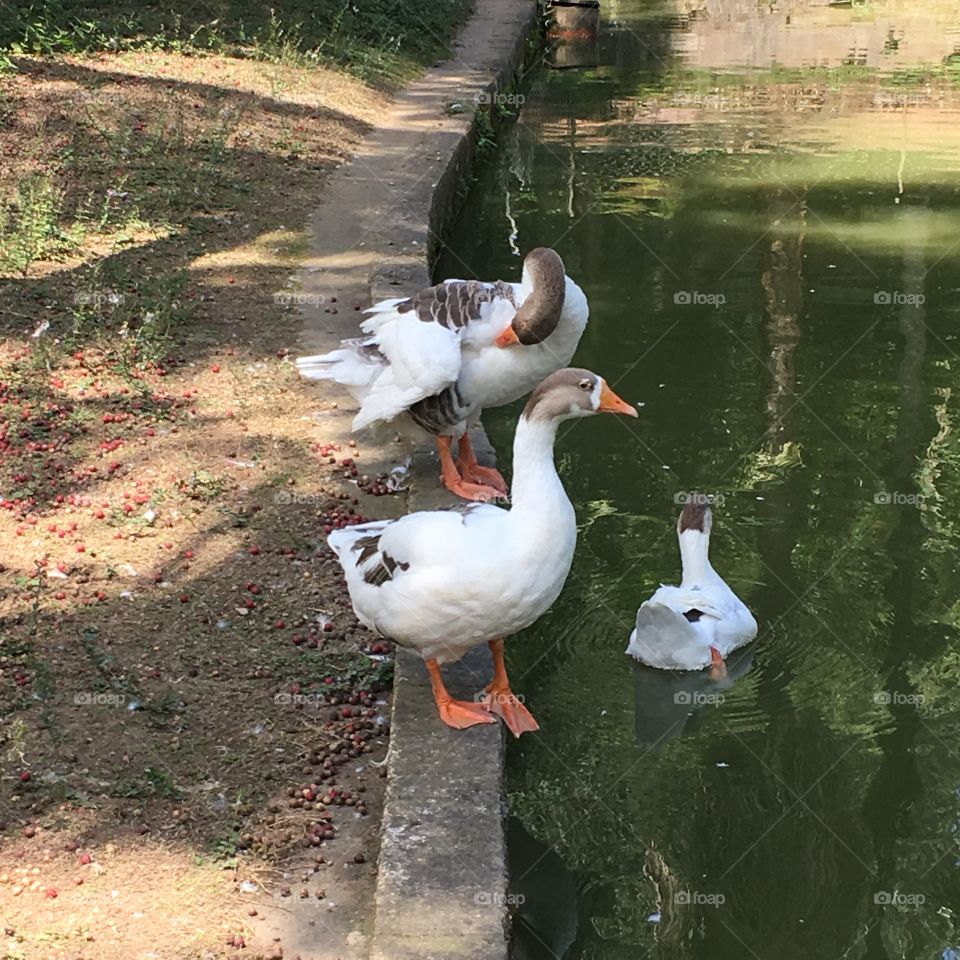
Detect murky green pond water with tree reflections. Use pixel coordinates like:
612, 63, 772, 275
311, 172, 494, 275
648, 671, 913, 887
436, 2, 960, 960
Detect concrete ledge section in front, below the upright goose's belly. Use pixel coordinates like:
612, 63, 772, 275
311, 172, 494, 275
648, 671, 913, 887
371, 649, 508, 960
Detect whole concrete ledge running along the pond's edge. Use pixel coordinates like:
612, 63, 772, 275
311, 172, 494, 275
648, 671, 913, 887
300, 0, 538, 960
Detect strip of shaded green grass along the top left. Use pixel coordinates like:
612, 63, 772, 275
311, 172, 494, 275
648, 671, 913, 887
0, 0, 471, 87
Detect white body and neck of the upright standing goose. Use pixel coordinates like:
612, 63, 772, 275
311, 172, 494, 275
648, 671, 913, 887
329, 418, 577, 664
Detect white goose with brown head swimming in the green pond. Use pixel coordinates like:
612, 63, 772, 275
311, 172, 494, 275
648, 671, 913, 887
626, 502, 757, 677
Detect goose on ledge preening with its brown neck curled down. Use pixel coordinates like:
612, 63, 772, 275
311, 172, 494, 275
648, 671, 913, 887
296, 247, 589, 500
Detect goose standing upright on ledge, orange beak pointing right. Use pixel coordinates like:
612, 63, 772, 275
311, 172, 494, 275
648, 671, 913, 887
327, 368, 637, 737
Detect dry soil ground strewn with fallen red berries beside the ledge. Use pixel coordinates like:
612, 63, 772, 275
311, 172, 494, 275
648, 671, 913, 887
0, 53, 400, 960
